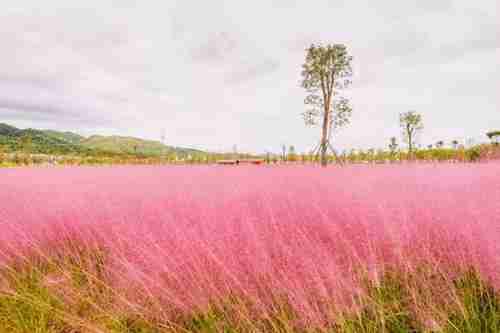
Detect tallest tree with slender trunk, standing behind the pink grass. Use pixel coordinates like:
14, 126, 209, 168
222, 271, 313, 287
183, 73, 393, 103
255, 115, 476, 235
301, 44, 352, 166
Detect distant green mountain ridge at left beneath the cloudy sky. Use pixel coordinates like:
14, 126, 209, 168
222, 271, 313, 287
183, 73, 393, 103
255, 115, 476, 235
0, 123, 205, 158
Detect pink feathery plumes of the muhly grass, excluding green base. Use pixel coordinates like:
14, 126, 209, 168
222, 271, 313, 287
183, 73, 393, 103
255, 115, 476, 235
0, 163, 500, 323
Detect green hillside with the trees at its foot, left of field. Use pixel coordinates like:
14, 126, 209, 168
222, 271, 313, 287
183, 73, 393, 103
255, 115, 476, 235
0, 123, 268, 167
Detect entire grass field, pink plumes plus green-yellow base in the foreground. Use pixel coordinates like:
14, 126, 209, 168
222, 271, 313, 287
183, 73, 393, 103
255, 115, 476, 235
0, 162, 500, 333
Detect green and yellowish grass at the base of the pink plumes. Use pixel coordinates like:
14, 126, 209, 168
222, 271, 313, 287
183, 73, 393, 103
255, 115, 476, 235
0, 258, 500, 333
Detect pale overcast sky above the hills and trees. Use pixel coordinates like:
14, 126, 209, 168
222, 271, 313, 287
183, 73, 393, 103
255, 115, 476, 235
0, 0, 500, 152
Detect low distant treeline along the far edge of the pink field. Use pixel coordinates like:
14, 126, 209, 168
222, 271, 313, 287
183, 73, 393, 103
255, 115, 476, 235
0, 144, 500, 167
